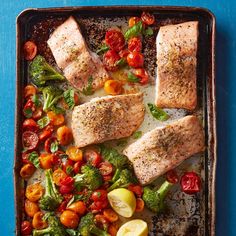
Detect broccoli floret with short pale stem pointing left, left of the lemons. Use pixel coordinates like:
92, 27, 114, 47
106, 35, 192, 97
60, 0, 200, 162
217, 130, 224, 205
74, 165, 102, 190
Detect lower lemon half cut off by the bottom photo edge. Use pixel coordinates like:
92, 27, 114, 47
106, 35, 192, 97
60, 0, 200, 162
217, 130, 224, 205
117, 219, 148, 236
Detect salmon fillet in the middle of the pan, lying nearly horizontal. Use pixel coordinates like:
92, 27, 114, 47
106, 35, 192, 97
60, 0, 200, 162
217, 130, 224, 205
71, 93, 145, 147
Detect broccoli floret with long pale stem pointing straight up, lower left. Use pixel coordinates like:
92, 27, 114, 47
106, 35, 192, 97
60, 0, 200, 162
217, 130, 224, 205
39, 169, 63, 211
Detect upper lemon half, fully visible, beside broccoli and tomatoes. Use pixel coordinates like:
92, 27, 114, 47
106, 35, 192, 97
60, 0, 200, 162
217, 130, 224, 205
107, 188, 136, 218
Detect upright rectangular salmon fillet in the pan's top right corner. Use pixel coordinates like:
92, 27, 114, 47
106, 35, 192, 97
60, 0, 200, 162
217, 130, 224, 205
155, 21, 198, 110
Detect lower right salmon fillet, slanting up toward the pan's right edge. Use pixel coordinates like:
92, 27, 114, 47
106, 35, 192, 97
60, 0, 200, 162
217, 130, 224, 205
123, 116, 205, 185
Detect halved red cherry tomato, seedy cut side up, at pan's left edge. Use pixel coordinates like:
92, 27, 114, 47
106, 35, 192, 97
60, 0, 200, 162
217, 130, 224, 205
22, 131, 39, 151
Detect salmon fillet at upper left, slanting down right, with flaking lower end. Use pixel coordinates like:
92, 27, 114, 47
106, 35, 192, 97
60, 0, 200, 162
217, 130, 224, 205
47, 16, 109, 90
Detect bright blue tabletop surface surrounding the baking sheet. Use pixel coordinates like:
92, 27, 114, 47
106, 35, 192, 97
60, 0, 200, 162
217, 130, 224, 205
0, 0, 232, 236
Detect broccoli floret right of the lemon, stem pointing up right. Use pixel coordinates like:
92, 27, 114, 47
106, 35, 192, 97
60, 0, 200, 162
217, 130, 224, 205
142, 181, 173, 213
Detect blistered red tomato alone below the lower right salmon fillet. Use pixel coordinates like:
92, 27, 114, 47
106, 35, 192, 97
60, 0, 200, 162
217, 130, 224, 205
180, 171, 201, 194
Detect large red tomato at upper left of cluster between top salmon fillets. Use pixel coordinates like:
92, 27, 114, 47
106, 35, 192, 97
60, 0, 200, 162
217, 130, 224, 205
105, 29, 125, 52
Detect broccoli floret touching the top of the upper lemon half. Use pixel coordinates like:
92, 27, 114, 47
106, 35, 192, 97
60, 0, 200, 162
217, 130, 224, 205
108, 169, 138, 191
